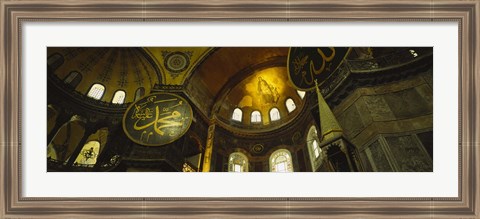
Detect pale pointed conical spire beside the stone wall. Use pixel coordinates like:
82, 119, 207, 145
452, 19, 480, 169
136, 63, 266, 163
315, 80, 343, 143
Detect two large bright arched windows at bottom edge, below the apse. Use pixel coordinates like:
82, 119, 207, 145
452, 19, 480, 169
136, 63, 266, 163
228, 149, 293, 172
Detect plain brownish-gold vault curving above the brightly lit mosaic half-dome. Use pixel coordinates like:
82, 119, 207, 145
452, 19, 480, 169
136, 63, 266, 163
185, 47, 288, 117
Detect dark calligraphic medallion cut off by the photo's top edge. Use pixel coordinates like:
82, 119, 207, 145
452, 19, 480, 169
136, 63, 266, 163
287, 47, 350, 91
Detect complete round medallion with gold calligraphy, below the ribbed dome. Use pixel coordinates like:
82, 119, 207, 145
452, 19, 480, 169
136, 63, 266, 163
123, 93, 193, 146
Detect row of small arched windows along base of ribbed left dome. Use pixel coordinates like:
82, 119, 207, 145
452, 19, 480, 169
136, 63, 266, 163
63, 71, 145, 104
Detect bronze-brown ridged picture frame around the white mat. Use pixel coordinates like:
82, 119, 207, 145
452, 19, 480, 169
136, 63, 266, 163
0, 0, 480, 218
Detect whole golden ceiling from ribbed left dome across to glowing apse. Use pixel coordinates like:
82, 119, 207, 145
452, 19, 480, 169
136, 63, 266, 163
47, 47, 304, 131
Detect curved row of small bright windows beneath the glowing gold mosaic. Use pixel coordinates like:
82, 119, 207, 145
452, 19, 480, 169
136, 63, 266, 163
232, 90, 305, 123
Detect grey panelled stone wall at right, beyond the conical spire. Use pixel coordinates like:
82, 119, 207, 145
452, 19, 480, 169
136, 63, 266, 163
333, 70, 433, 172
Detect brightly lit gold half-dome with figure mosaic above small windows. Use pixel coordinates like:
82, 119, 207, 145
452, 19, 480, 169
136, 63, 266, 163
217, 67, 303, 128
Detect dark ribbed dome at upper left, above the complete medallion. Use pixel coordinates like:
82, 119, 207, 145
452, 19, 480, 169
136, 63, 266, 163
48, 47, 160, 103
